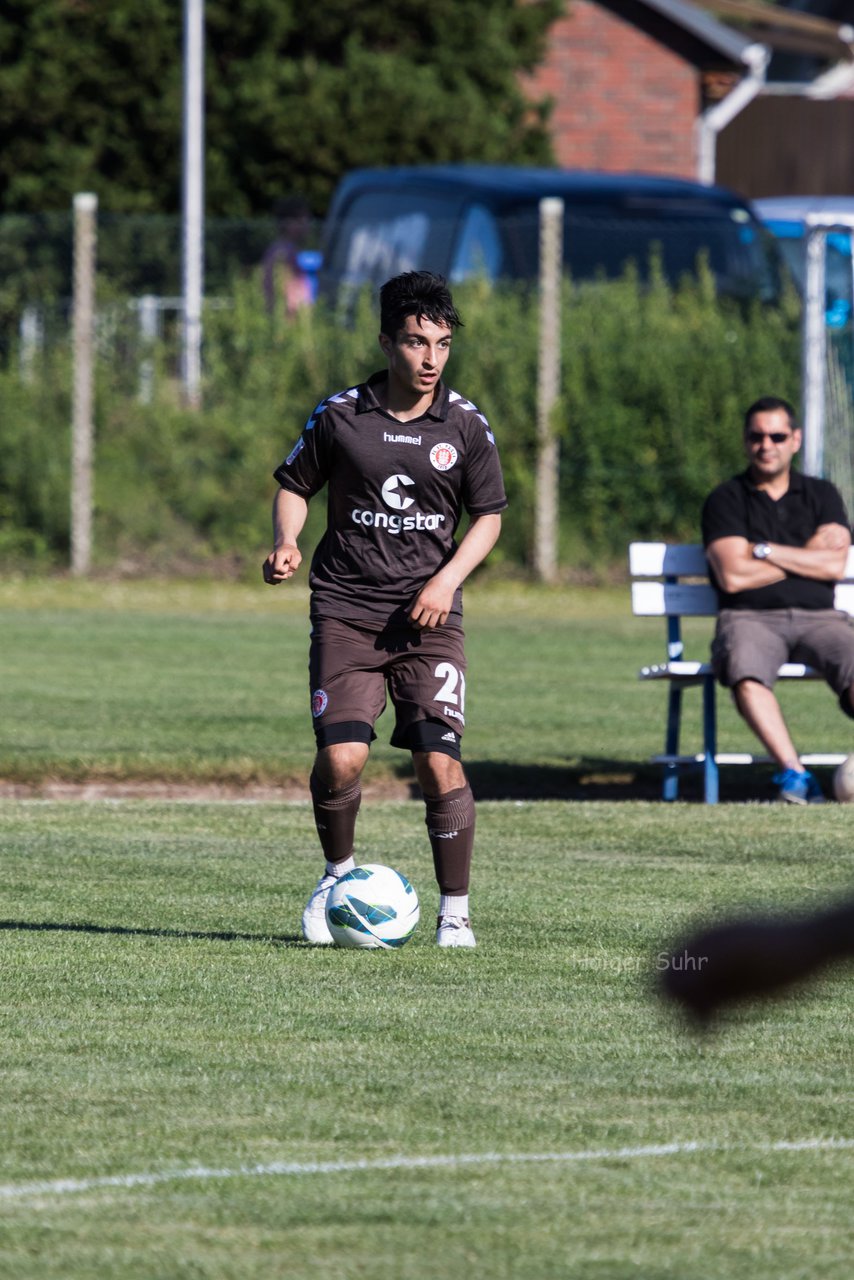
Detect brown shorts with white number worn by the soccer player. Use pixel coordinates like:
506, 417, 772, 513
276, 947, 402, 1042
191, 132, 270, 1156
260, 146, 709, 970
309, 618, 466, 759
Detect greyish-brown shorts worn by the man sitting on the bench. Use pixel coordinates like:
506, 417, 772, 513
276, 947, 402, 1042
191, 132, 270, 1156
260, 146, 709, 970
712, 609, 854, 709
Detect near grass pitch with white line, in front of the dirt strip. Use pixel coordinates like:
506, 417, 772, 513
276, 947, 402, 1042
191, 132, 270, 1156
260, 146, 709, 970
0, 801, 854, 1280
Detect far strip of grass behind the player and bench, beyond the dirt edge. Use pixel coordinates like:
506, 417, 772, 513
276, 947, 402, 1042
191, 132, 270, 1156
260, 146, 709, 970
0, 580, 851, 799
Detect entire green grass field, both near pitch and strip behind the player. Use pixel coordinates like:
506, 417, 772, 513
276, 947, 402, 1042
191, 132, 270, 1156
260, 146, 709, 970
0, 582, 854, 1280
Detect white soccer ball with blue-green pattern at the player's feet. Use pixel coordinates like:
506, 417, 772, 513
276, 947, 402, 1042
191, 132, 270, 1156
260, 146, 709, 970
326, 863, 420, 950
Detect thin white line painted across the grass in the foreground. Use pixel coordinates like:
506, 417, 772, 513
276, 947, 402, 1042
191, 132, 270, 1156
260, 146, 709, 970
0, 1138, 854, 1202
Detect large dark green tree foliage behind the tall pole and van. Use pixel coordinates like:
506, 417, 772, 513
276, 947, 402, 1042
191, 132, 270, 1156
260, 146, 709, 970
0, 0, 565, 216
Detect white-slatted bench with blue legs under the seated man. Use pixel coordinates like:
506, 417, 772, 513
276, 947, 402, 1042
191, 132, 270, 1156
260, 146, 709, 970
629, 543, 854, 804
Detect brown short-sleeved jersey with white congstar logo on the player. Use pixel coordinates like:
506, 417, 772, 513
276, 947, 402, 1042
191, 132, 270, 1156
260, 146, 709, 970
274, 372, 507, 626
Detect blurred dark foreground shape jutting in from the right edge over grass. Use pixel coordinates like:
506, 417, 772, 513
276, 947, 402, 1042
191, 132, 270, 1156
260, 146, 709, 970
658, 899, 854, 1024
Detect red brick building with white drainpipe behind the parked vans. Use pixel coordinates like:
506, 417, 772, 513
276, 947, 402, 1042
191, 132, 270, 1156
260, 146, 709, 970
525, 0, 854, 196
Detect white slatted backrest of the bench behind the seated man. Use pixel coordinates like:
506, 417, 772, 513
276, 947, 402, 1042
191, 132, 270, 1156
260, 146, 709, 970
629, 543, 854, 618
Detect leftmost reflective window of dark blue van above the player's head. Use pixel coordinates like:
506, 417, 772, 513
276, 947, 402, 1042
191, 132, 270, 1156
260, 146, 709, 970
324, 191, 458, 285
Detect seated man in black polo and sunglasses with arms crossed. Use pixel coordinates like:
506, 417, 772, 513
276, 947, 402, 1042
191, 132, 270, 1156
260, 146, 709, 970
703, 396, 854, 804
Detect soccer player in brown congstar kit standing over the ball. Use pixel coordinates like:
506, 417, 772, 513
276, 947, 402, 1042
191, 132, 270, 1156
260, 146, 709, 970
264, 271, 507, 947
